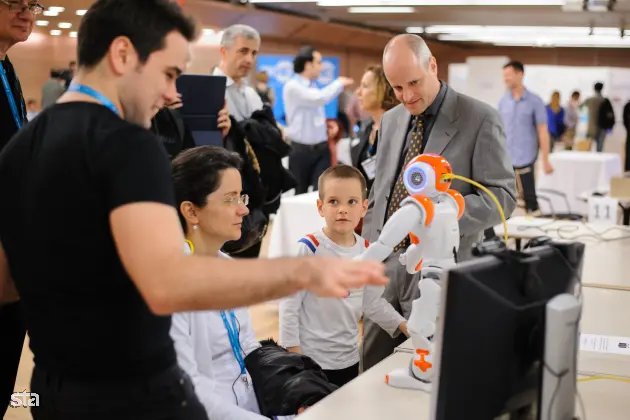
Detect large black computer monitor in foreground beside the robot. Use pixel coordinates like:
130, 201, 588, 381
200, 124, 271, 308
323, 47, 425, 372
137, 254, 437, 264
430, 243, 584, 420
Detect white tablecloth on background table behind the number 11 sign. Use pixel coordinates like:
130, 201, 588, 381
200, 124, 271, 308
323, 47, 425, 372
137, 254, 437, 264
536, 151, 623, 215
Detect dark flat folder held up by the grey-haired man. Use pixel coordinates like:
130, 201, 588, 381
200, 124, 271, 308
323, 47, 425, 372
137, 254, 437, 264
177, 74, 227, 146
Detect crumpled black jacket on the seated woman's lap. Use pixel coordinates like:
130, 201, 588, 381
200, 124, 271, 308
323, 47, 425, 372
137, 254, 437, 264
245, 340, 337, 418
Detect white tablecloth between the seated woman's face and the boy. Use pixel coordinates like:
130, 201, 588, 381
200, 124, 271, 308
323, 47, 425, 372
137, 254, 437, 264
268, 191, 324, 258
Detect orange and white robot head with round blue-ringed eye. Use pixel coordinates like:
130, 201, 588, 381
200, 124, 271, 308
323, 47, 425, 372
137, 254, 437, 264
403, 153, 453, 195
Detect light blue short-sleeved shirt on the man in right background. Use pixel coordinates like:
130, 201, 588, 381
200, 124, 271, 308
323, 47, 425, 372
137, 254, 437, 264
499, 89, 547, 168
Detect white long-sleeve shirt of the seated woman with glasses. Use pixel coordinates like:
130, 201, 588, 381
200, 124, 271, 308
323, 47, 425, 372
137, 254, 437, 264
171, 248, 268, 420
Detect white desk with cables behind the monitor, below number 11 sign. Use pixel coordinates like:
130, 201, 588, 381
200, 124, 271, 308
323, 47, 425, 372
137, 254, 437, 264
495, 216, 630, 288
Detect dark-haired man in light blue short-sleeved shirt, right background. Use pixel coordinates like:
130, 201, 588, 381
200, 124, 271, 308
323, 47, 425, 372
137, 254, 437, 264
499, 61, 553, 213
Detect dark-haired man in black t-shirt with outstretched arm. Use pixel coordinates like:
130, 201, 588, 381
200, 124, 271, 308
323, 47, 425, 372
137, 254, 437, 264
0, 0, 387, 420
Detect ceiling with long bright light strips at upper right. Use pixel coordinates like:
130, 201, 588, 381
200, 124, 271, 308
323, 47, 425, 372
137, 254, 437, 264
239, 0, 630, 47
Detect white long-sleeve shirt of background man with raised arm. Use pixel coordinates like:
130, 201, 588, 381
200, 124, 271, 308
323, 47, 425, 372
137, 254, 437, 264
282, 75, 344, 145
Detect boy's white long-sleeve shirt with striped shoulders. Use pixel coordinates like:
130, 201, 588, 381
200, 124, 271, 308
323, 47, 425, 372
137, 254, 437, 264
279, 231, 405, 370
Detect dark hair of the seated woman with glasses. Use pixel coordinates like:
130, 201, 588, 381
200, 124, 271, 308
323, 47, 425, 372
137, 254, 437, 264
171, 146, 243, 230
